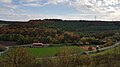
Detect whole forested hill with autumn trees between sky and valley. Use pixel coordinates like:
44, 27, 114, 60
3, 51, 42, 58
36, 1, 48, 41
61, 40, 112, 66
0, 19, 120, 44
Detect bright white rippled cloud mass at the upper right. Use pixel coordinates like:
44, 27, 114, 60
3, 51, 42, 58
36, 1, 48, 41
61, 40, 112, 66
63, 0, 120, 20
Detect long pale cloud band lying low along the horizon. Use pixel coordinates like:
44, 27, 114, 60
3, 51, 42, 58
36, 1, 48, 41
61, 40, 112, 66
0, 13, 119, 21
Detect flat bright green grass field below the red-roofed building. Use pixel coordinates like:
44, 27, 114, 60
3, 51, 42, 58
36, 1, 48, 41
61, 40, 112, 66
27, 46, 84, 57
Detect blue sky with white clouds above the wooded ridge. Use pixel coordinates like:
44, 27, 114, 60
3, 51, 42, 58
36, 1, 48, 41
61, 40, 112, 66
0, 0, 120, 21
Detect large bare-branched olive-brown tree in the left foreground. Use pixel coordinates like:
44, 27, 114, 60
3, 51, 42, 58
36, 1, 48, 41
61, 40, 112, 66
5, 47, 34, 67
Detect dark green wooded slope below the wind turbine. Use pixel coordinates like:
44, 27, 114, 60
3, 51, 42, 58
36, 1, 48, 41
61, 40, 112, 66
33, 21, 120, 32
